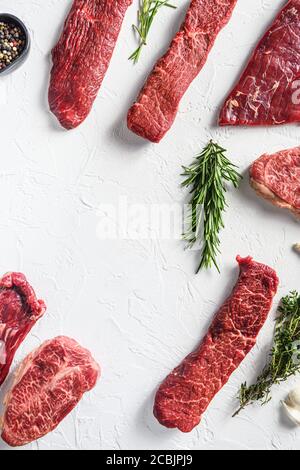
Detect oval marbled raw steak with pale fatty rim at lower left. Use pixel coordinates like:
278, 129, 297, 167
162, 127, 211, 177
1, 336, 100, 447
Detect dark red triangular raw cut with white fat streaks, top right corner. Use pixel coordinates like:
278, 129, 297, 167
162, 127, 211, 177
219, 0, 300, 126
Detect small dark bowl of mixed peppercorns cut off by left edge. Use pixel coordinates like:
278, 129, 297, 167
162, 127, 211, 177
0, 13, 30, 75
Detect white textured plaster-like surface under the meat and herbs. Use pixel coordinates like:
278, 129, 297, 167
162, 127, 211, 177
0, 0, 300, 449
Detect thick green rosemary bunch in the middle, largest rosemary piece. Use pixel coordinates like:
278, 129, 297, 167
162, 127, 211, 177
182, 140, 242, 273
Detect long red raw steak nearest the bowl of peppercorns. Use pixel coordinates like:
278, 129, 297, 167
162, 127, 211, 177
49, 0, 132, 129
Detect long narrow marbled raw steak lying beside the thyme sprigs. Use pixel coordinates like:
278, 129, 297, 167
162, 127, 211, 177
154, 257, 278, 432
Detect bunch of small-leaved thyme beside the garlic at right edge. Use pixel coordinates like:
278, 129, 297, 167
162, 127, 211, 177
233, 291, 300, 416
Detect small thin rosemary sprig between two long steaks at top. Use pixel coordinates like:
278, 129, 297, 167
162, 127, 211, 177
129, 0, 176, 64
